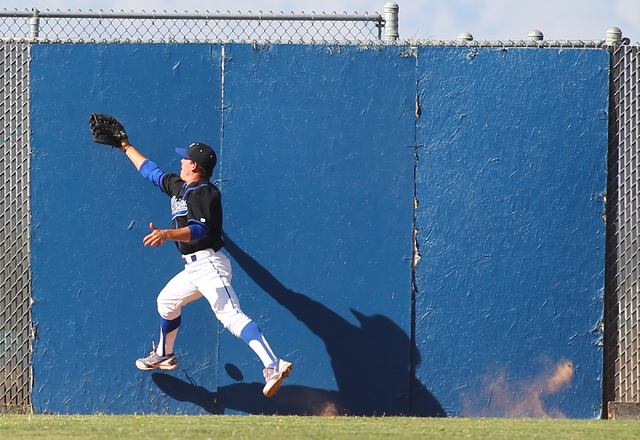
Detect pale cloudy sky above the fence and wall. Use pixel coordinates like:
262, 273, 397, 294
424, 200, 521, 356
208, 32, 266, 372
0, 0, 640, 45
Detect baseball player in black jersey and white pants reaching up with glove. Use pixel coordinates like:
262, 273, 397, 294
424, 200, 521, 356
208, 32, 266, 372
90, 113, 292, 397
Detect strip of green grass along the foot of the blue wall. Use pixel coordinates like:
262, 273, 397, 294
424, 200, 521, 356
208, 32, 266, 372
0, 415, 640, 440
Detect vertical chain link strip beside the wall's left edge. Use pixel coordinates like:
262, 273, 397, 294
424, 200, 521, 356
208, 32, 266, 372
0, 44, 32, 412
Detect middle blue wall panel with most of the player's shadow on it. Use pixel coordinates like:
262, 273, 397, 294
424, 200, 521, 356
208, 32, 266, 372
212, 45, 415, 414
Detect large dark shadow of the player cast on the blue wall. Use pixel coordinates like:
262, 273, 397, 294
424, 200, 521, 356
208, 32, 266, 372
152, 236, 446, 417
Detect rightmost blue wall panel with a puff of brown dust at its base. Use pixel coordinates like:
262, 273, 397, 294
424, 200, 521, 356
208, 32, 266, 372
416, 48, 609, 417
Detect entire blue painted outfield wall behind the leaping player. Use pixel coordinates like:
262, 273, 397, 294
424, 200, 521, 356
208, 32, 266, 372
31, 44, 608, 418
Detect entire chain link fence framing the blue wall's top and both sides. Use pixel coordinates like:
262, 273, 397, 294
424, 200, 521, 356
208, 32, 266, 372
0, 2, 640, 412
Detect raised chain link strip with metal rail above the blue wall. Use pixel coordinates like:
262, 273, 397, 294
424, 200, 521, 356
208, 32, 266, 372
0, 9, 388, 43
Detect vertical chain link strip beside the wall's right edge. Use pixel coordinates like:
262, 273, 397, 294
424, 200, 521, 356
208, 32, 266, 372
604, 46, 640, 408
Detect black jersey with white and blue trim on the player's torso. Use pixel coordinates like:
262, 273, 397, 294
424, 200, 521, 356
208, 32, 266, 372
159, 173, 224, 254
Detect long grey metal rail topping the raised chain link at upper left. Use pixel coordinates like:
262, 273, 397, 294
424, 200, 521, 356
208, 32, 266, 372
0, 9, 385, 23
